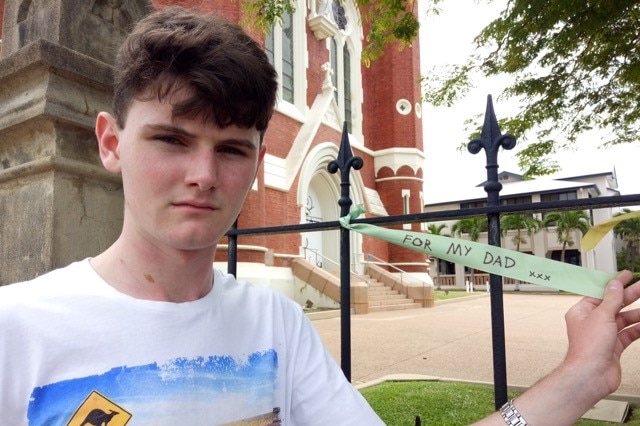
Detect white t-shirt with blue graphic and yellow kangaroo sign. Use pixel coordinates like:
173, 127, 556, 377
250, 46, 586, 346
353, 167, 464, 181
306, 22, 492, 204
0, 260, 383, 426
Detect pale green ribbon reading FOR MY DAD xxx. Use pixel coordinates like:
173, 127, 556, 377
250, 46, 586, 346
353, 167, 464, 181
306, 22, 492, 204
340, 206, 617, 299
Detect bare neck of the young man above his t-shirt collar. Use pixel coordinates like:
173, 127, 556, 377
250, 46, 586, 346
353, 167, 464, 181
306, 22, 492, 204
91, 238, 215, 303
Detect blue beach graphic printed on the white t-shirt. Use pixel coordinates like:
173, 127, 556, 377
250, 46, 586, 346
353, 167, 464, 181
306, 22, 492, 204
27, 350, 281, 425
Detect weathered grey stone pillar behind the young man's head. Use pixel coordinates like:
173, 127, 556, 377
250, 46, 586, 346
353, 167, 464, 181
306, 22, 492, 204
0, 0, 150, 285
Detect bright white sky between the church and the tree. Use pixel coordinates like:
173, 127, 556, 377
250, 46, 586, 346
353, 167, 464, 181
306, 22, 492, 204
420, 0, 640, 204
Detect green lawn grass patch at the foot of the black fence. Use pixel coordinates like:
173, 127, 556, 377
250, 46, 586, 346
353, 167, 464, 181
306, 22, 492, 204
360, 381, 640, 426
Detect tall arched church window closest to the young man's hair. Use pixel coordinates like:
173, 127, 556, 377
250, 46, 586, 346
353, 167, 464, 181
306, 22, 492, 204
265, 0, 306, 116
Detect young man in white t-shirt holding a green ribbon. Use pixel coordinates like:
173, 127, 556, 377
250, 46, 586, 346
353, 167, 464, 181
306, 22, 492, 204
0, 4, 640, 426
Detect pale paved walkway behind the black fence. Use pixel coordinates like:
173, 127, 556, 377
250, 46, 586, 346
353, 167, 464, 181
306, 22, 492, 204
313, 293, 640, 400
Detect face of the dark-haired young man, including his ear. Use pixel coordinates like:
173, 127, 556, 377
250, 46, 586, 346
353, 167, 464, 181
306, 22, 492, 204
96, 88, 265, 250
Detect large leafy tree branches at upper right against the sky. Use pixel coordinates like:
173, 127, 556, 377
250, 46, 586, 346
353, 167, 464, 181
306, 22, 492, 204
425, 0, 640, 176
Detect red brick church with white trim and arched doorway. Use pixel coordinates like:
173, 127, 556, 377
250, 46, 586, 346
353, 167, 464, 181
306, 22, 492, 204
0, 0, 428, 306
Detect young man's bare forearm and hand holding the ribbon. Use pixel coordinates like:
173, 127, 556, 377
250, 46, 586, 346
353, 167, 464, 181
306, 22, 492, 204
476, 271, 640, 426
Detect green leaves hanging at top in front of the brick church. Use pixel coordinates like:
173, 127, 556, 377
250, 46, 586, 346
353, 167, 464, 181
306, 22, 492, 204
242, 0, 420, 64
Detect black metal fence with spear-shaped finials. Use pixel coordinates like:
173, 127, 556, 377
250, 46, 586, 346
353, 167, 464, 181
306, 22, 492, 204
227, 96, 640, 409
